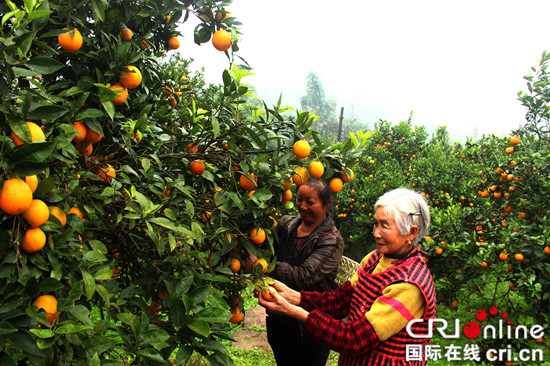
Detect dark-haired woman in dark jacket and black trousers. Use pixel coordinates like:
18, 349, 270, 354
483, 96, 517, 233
266, 179, 344, 366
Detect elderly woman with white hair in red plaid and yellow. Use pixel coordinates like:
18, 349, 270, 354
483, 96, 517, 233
259, 188, 436, 365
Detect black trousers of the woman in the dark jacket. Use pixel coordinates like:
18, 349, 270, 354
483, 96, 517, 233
266, 315, 330, 366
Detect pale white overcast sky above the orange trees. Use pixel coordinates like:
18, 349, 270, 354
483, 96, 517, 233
180, 0, 550, 140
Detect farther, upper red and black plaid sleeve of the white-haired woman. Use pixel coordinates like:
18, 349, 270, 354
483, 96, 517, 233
300, 281, 353, 319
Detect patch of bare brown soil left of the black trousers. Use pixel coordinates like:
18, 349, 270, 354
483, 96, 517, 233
231, 306, 271, 350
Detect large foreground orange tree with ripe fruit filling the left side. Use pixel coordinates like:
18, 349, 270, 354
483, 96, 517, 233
0, 0, 367, 365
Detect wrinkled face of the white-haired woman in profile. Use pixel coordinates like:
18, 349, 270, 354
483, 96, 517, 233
373, 207, 414, 254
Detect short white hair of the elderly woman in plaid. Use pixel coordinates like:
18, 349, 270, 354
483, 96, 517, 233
374, 188, 430, 245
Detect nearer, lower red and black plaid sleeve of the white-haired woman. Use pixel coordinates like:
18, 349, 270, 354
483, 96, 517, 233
305, 309, 380, 356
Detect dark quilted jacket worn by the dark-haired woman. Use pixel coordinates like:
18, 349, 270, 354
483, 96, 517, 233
270, 215, 344, 292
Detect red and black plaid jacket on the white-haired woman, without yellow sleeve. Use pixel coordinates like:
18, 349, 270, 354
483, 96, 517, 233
300, 249, 436, 365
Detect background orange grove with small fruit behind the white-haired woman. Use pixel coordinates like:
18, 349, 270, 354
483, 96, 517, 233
335, 53, 550, 349
